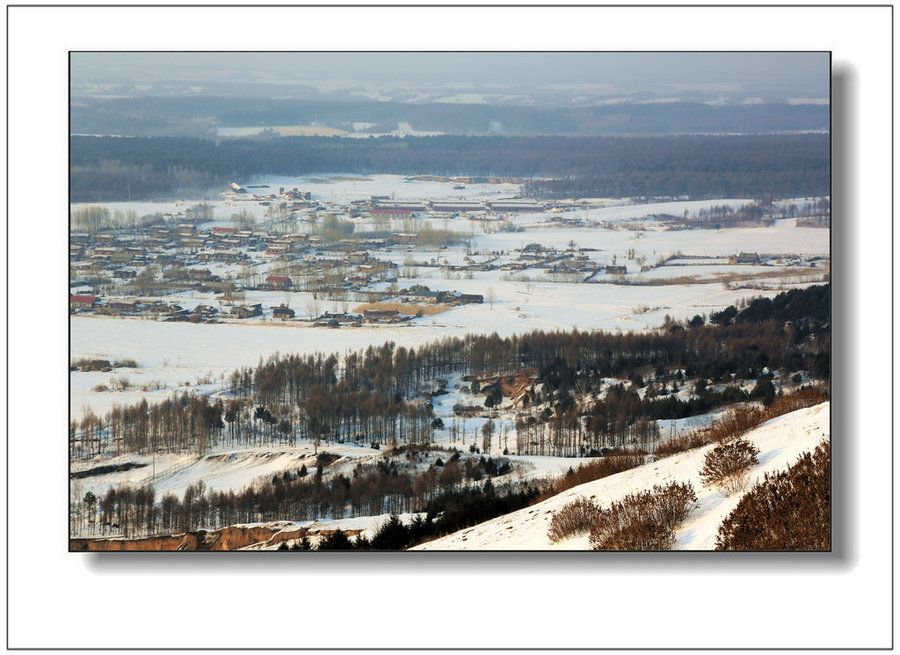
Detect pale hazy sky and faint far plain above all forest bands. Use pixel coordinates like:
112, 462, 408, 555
72, 53, 830, 100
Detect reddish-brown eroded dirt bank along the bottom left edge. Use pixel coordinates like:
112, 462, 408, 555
69, 524, 361, 551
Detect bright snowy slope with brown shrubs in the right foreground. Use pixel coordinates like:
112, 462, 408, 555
413, 403, 830, 550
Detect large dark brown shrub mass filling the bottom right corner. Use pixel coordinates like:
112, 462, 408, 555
716, 442, 831, 550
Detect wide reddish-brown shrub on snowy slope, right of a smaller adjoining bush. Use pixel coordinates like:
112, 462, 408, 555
590, 482, 697, 550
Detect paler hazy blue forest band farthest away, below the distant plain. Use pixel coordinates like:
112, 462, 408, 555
71, 97, 829, 136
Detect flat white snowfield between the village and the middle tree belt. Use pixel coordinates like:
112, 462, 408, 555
70, 271, 816, 418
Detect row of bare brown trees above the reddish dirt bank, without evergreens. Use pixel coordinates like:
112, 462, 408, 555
72, 454, 511, 537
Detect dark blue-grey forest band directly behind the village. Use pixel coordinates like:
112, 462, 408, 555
70, 134, 830, 202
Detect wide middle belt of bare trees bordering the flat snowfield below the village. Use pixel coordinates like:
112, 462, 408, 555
70, 285, 830, 459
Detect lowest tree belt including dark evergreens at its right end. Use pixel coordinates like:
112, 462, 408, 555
73, 449, 537, 548
